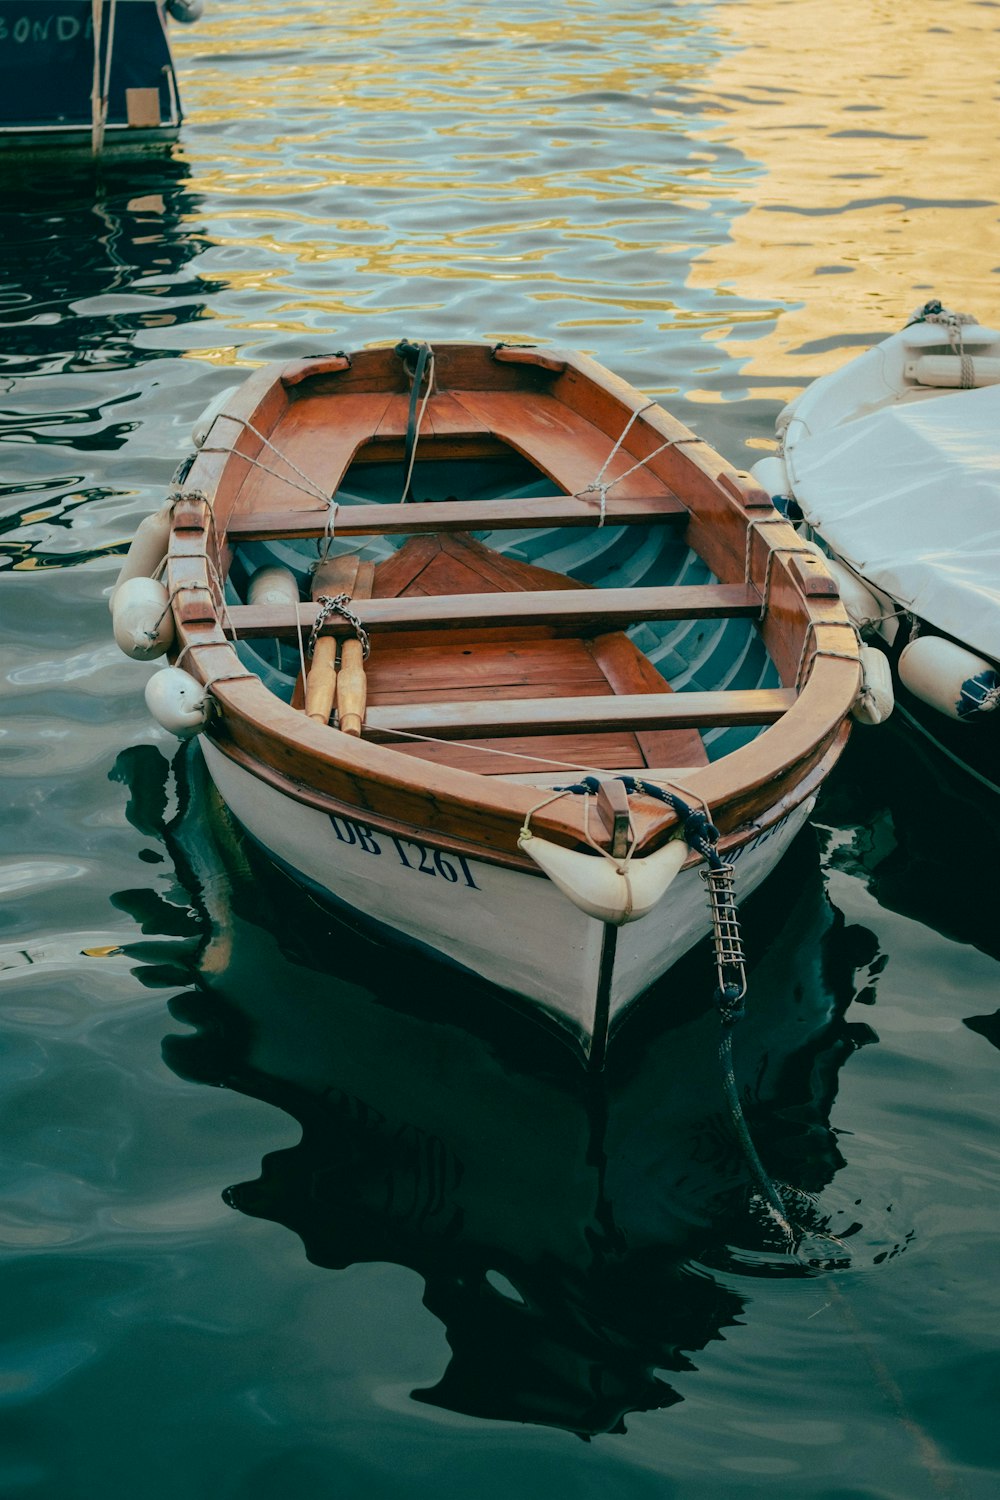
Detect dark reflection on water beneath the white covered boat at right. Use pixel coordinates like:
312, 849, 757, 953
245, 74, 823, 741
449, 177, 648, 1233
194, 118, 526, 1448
823, 717, 1000, 1047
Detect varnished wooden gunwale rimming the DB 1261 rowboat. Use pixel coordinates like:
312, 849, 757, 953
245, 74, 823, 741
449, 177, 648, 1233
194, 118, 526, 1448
169, 347, 859, 864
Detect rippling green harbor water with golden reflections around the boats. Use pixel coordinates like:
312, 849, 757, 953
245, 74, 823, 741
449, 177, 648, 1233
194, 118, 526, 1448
0, 0, 1000, 1500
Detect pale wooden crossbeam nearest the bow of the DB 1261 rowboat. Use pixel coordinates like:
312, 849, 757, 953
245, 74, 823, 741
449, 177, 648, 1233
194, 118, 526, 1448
364, 687, 796, 740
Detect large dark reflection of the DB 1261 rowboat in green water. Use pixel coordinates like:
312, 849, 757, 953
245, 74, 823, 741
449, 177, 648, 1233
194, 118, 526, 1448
114, 747, 874, 1436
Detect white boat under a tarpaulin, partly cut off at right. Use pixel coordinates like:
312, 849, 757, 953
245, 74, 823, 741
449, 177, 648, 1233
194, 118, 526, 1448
754, 302, 1000, 789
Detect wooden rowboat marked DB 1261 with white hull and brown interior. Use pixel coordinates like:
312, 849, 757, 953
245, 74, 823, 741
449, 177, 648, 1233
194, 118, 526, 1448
121, 344, 859, 1053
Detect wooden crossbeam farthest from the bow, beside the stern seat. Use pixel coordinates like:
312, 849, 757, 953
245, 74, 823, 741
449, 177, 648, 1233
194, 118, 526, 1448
228, 494, 688, 542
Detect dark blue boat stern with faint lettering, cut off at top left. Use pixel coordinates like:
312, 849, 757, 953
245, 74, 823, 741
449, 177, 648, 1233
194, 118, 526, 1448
0, 0, 204, 158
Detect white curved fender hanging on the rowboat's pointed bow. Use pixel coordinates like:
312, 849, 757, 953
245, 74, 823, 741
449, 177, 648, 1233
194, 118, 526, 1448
517, 831, 690, 927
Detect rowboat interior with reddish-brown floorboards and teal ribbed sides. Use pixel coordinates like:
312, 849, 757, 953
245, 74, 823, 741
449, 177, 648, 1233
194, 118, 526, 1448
218, 363, 778, 782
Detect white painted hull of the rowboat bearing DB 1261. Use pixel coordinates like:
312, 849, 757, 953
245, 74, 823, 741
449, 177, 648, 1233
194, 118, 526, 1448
199, 740, 813, 1047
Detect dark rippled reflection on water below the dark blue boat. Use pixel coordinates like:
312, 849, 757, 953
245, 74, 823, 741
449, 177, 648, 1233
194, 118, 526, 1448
0, 153, 222, 572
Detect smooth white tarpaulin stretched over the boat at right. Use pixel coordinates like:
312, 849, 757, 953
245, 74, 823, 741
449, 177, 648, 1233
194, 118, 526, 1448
786, 386, 1000, 660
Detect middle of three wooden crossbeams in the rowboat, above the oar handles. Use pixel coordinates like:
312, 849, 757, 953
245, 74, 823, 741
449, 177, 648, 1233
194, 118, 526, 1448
226, 584, 760, 639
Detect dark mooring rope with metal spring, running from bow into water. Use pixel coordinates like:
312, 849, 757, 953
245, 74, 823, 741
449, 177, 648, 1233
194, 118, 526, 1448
558, 776, 795, 1251
